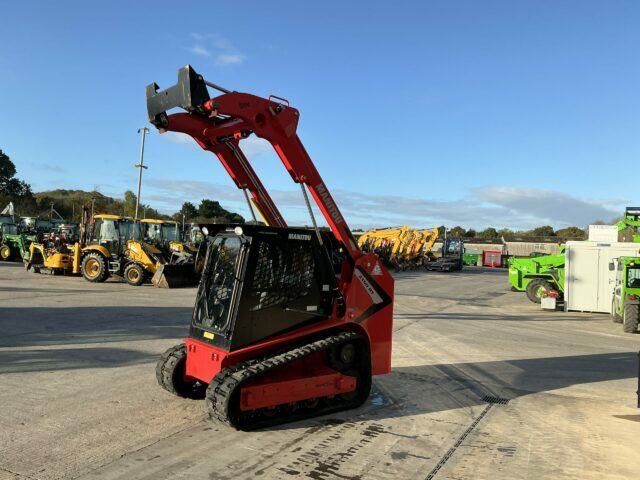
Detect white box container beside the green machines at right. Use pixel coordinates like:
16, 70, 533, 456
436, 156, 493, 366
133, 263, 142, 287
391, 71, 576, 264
564, 241, 640, 313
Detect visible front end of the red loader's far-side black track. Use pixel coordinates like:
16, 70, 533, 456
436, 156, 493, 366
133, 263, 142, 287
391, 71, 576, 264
156, 343, 206, 399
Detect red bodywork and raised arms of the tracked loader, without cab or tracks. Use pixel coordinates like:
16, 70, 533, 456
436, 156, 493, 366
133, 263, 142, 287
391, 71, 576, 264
147, 66, 394, 428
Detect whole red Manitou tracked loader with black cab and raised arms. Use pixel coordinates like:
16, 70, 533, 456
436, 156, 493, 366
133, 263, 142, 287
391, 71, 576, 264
147, 66, 393, 430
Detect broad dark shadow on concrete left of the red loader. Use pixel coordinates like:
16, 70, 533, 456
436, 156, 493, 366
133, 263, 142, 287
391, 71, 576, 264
0, 306, 192, 374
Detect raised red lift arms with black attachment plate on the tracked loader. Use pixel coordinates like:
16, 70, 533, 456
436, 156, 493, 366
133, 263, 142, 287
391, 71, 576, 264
147, 65, 362, 259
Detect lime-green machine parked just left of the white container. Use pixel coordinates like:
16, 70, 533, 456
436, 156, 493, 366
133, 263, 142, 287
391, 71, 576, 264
509, 247, 565, 303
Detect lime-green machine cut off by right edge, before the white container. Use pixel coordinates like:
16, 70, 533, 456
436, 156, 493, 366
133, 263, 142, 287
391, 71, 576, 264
609, 257, 640, 333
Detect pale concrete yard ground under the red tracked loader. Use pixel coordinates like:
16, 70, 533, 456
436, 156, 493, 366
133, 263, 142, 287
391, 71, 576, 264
0, 263, 640, 480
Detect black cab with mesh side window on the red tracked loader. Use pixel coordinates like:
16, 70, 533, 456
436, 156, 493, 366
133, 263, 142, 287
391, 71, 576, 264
190, 225, 335, 350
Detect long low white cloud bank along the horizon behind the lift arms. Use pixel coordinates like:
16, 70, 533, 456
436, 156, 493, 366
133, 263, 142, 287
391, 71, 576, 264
141, 179, 624, 230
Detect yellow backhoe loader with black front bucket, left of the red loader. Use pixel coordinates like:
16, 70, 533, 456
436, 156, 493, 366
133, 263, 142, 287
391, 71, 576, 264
26, 214, 195, 288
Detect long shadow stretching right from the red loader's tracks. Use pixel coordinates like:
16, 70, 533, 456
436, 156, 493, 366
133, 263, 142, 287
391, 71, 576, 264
275, 352, 638, 429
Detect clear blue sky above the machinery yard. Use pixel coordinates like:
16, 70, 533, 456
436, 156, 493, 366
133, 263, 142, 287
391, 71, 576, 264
0, 0, 640, 228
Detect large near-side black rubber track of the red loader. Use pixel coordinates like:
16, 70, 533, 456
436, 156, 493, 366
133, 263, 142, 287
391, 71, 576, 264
206, 332, 364, 430
